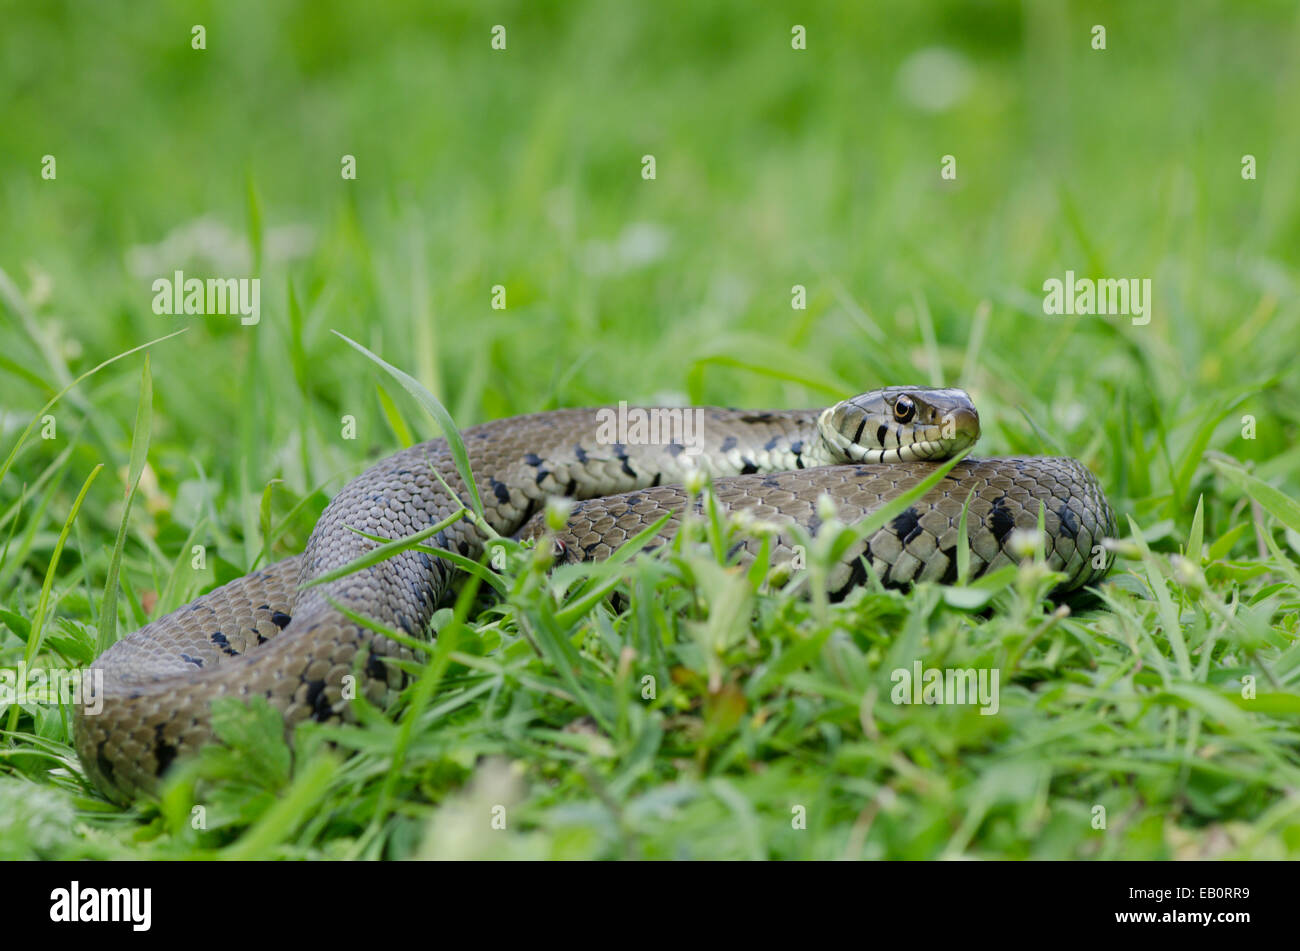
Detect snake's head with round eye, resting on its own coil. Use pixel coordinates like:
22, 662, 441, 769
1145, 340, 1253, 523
818, 386, 979, 463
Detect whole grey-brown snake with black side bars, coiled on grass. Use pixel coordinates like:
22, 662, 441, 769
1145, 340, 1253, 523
74, 387, 1114, 799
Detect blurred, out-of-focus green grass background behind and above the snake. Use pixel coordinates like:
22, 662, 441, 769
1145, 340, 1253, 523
0, 0, 1300, 862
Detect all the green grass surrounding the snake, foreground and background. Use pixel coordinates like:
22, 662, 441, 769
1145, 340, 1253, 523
0, 0, 1300, 859
